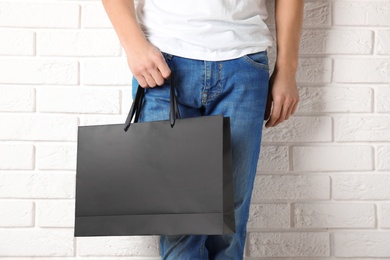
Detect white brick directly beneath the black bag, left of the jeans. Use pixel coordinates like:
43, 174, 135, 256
77, 236, 159, 256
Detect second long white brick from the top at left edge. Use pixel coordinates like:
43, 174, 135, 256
0, 59, 78, 85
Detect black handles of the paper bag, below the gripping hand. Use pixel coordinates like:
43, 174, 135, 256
124, 75, 180, 132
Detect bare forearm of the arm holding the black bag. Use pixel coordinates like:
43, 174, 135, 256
102, 0, 146, 54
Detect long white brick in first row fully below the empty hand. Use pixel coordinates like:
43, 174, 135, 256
293, 145, 373, 171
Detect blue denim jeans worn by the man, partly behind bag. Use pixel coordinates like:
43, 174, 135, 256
133, 51, 269, 260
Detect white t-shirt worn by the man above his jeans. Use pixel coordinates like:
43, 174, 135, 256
136, 0, 273, 61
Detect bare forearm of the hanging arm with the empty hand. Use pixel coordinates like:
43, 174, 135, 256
275, 0, 303, 74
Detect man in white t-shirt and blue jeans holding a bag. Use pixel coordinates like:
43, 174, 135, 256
102, 0, 303, 260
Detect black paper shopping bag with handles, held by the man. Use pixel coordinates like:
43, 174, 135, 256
74, 84, 235, 236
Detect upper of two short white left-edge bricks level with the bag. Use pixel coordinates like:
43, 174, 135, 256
0, 143, 34, 170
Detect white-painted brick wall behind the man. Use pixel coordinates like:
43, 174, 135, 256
0, 0, 390, 260
